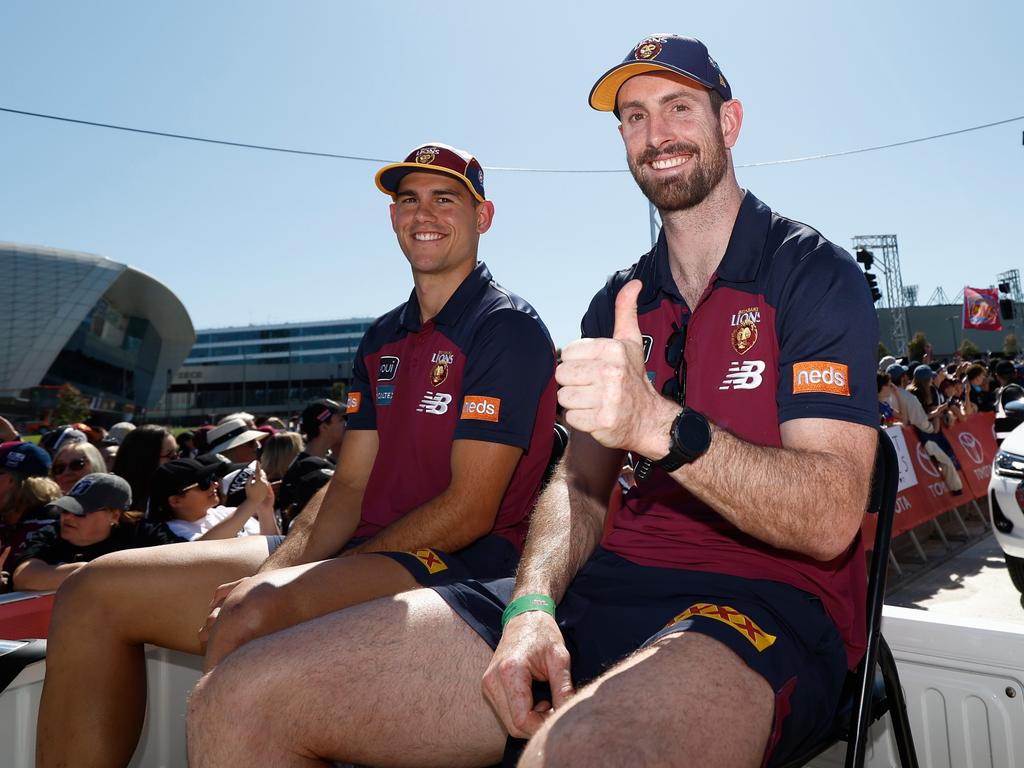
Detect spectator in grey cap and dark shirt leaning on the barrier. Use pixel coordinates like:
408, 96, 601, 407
13, 473, 184, 590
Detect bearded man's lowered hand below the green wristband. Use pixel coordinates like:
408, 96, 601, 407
482, 611, 575, 738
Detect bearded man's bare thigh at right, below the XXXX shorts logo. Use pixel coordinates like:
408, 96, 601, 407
519, 632, 774, 768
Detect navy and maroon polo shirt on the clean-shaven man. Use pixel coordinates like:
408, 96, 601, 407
347, 262, 555, 550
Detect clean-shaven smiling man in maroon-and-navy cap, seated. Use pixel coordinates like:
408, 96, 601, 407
37, 143, 555, 766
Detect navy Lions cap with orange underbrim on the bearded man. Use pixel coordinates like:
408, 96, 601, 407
590, 35, 732, 117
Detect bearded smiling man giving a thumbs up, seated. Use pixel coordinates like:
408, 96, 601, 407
189, 40, 878, 768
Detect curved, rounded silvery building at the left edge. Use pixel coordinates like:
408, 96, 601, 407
0, 243, 196, 424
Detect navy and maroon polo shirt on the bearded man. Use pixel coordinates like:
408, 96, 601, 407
583, 193, 879, 666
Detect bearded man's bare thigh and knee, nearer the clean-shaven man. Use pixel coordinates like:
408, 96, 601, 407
188, 590, 505, 768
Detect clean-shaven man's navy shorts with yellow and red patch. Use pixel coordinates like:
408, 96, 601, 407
374, 534, 519, 589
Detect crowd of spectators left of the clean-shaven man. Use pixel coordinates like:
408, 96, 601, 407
0, 399, 345, 591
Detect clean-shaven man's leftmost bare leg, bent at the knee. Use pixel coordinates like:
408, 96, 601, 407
36, 537, 267, 768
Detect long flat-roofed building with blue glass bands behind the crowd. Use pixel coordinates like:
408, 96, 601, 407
150, 317, 373, 424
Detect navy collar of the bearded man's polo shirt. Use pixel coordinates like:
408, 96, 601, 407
636, 191, 772, 303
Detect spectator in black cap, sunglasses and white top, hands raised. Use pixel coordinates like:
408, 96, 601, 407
148, 459, 281, 542
